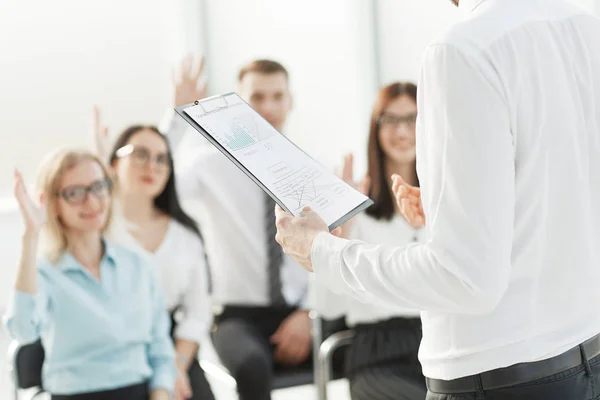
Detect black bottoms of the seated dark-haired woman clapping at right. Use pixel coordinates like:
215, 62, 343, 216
346, 318, 427, 400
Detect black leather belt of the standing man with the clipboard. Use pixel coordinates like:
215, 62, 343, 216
426, 334, 600, 394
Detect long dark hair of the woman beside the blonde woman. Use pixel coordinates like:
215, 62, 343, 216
109, 125, 202, 239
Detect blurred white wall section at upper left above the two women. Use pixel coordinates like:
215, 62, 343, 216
0, 0, 182, 197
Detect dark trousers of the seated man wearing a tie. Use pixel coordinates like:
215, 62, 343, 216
212, 306, 310, 400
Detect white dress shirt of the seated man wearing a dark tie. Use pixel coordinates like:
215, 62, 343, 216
161, 112, 310, 313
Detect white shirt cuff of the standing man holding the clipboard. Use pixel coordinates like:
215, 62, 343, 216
311, 232, 349, 293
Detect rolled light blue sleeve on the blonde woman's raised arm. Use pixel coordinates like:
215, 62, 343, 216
3, 290, 44, 344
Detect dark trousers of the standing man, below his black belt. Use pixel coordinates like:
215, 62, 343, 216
427, 356, 600, 400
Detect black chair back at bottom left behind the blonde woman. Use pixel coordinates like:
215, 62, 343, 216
8, 340, 44, 400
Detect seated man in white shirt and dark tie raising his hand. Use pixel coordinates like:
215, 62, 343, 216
163, 60, 311, 400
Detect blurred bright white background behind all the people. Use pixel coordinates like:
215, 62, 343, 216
0, 0, 600, 398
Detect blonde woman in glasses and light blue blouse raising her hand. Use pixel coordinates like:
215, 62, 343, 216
5, 150, 176, 400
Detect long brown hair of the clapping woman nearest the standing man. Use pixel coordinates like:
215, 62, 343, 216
366, 82, 419, 220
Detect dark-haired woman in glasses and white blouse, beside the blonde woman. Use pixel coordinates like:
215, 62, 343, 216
95, 113, 214, 400
